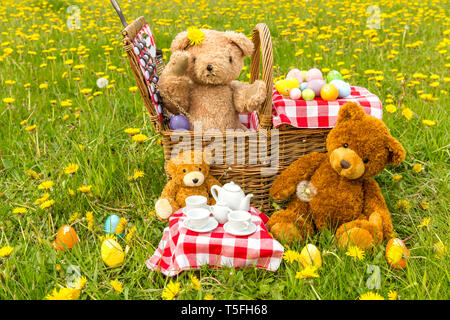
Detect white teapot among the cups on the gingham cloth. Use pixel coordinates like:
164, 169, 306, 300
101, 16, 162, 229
211, 181, 253, 211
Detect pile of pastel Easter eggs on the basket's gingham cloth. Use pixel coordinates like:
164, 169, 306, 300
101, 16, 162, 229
275, 68, 351, 101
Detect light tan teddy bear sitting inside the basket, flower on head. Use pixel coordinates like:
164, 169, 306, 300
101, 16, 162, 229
159, 29, 266, 131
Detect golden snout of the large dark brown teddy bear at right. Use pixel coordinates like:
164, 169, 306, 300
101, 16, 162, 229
330, 147, 365, 180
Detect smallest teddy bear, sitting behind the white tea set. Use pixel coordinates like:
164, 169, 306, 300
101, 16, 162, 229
155, 151, 222, 221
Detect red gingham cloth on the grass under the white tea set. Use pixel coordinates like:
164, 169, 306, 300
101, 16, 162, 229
145, 207, 284, 277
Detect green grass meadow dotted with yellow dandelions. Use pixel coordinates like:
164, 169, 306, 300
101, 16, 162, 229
0, 0, 450, 299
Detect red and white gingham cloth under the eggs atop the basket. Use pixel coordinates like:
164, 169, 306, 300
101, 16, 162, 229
272, 86, 383, 128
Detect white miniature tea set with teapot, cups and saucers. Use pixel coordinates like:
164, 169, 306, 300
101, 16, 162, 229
182, 181, 256, 236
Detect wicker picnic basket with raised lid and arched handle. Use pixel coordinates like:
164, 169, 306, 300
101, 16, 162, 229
122, 17, 329, 212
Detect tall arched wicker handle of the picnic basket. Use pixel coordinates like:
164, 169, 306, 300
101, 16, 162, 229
250, 23, 273, 129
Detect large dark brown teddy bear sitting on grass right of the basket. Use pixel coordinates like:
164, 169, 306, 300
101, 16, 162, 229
268, 102, 405, 248
